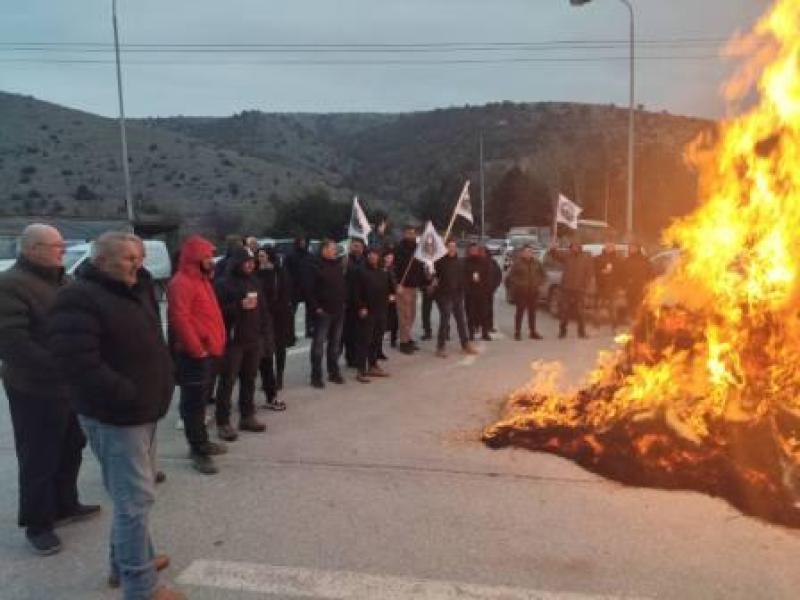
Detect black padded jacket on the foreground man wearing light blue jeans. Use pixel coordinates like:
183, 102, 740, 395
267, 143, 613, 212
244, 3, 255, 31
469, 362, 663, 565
49, 264, 174, 427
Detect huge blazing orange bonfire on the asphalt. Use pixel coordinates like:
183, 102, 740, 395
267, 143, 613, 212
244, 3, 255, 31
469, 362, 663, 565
484, 0, 800, 523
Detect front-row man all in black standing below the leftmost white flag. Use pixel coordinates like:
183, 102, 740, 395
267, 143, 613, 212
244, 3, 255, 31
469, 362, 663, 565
355, 247, 394, 383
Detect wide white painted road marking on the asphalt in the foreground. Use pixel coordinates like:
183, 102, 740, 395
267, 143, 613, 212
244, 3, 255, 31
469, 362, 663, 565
178, 560, 648, 600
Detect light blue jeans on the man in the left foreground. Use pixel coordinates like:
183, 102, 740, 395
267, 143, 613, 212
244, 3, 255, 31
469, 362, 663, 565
79, 416, 158, 600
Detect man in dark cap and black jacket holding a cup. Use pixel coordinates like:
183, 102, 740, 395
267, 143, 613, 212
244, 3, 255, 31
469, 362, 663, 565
214, 248, 271, 441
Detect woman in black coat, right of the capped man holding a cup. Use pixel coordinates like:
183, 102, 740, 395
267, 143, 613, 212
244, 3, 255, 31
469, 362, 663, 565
256, 247, 296, 410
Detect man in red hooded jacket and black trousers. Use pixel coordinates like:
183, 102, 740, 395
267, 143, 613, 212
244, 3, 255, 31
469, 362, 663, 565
167, 236, 226, 475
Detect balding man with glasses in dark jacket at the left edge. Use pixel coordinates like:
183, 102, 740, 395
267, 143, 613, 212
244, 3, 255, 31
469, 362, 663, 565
0, 224, 100, 555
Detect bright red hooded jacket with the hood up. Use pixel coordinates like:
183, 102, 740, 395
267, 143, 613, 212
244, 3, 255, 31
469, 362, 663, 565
167, 236, 225, 358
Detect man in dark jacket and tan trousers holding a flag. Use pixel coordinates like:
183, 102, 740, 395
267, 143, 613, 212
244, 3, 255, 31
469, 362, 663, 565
394, 226, 425, 354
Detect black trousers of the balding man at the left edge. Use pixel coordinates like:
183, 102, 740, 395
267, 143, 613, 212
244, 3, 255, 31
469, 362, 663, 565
4, 385, 86, 533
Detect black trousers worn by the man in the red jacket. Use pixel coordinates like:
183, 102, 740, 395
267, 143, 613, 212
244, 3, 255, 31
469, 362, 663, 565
175, 353, 214, 454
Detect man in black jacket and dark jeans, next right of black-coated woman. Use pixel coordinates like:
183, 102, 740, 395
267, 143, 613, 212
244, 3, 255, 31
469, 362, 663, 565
307, 240, 347, 388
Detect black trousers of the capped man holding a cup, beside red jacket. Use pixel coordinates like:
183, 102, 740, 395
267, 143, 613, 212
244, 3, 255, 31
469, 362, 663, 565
216, 342, 261, 425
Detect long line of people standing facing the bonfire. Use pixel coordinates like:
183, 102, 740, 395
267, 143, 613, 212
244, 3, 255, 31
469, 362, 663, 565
0, 224, 650, 600
